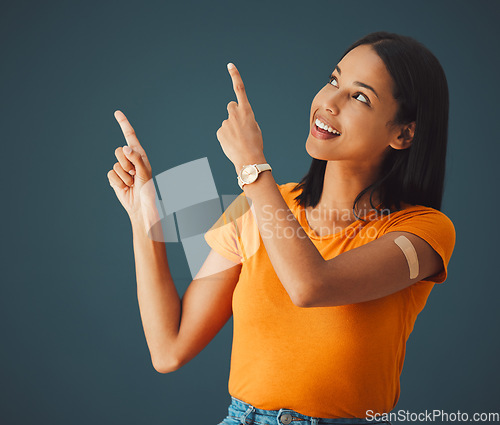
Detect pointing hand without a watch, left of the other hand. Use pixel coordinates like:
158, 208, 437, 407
108, 111, 155, 220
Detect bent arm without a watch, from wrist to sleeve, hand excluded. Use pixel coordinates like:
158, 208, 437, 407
132, 215, 241, 373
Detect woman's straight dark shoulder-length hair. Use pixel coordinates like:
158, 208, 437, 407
292, 31, 449, 219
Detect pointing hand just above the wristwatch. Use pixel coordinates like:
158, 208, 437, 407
217, 63, 266, 173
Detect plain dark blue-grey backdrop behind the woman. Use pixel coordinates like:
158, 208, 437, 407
0, 0, 500, 425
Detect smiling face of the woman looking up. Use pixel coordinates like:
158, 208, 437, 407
306, 45, 408, 168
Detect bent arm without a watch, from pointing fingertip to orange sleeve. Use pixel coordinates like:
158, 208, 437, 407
108, 111, 241, 373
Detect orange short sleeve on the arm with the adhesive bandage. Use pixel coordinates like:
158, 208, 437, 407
384, 207, 456, 283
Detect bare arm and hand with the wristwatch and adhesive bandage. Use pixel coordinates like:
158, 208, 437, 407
217, 64, 443, 307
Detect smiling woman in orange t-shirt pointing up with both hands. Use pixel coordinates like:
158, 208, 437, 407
108, 32, 455, 425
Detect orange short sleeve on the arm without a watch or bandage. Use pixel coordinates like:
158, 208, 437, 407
204, 192, 251, 263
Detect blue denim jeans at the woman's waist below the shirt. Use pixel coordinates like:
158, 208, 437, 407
218, 396, 391, 425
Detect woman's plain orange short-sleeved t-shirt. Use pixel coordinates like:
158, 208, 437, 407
205, 183, 455, 418
